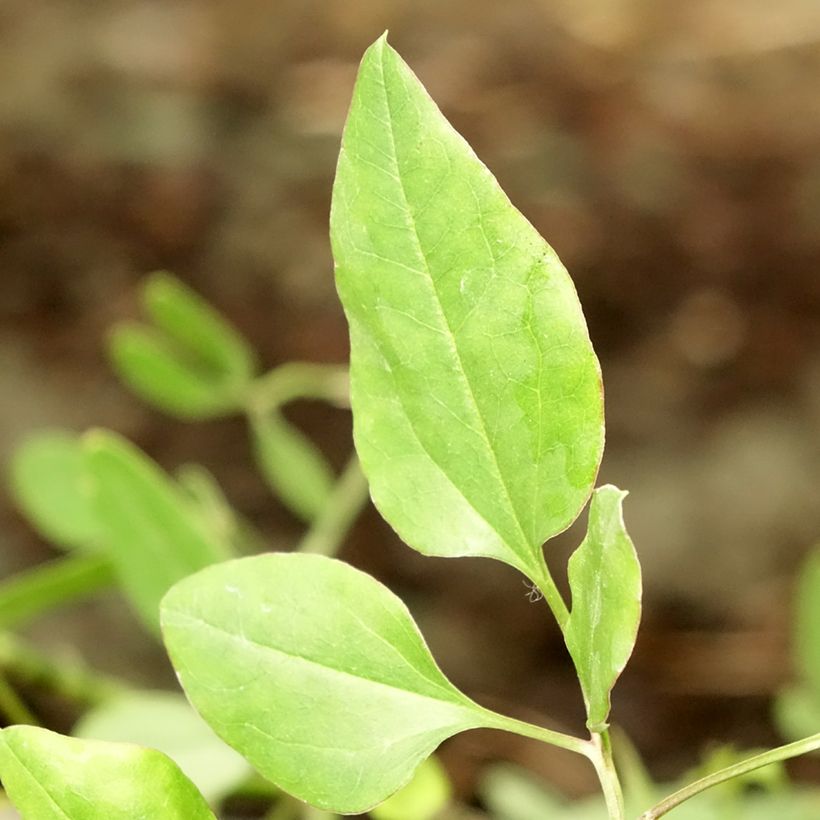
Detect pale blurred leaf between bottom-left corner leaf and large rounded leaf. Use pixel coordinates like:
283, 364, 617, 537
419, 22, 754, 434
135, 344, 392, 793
72, 691, 251, 803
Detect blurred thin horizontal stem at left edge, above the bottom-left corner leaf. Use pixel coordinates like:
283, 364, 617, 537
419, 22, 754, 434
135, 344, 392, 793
0, 632, 126, 706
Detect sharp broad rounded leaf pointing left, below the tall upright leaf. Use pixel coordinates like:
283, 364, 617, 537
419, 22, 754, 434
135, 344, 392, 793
162, 554, 496, 814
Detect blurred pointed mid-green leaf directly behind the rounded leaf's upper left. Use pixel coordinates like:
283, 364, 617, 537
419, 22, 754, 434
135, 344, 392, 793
85, 431, 231, 631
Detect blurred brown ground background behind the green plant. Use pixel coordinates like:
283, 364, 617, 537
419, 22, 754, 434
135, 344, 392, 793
0, 0, 820, 808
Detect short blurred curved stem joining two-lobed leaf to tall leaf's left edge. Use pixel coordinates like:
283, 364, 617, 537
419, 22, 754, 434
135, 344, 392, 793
247, 362, 350, 414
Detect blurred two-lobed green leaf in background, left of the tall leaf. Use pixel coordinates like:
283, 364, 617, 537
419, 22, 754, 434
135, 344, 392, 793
109, 273, 256, 419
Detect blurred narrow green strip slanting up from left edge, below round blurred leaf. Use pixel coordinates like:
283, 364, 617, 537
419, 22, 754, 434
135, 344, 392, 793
0, 553, 114, 629
